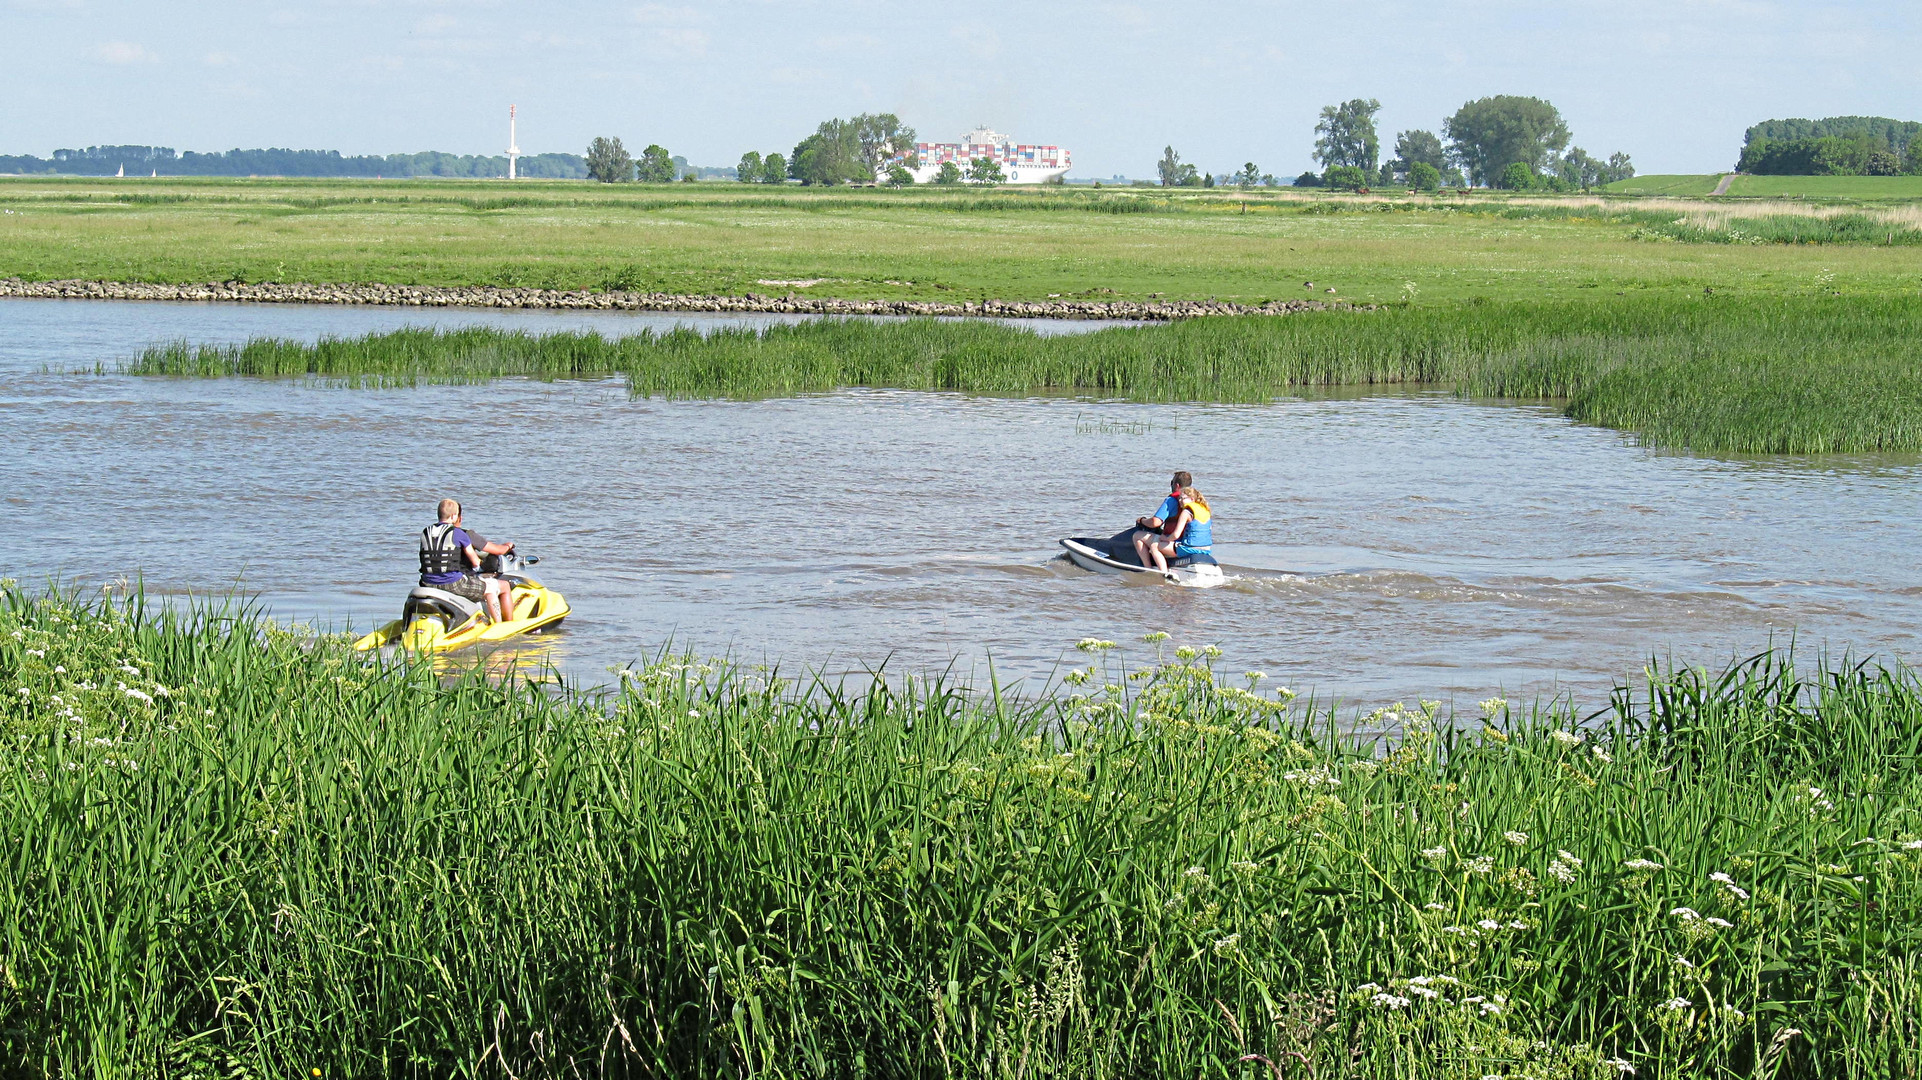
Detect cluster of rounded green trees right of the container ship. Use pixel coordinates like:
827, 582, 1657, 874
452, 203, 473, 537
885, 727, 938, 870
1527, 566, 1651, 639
1157, 94, 1636, 190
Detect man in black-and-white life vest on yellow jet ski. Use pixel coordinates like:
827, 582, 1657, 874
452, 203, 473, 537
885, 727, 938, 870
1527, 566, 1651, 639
354, 500, 569, 651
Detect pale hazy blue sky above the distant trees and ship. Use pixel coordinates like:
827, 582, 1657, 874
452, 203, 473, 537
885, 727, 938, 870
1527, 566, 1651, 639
0, 0, 1922, 177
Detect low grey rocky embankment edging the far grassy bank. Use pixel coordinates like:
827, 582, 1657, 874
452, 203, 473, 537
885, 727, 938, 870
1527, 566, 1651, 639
0, 279, 1374, 321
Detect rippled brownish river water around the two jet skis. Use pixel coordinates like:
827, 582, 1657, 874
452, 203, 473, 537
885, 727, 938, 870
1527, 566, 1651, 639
0, 300, 1922, 709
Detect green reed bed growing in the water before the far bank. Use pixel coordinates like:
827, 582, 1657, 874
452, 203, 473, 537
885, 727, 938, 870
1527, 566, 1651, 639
121, 295, 1922, 454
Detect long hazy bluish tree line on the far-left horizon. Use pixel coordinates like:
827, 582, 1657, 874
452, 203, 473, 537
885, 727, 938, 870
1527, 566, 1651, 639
0, 146, 588, 179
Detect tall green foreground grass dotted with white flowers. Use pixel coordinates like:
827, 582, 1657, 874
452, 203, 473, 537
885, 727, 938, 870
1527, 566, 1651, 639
0, 584, 1922, 1078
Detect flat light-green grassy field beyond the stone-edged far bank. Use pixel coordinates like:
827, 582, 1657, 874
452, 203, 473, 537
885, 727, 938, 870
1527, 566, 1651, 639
0, 179, 1922, 302
